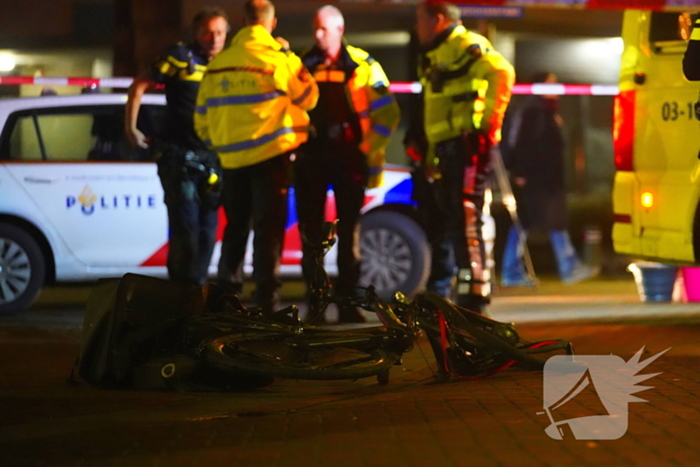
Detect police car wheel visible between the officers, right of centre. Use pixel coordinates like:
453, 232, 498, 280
360, 211, 430, 299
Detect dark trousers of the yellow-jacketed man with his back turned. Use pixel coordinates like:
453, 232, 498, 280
217, 153, 290, 311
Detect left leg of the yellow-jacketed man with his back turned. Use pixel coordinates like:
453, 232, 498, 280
217, 167, 252, 294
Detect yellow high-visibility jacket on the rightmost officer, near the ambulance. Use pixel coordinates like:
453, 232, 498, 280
419, 25, 515, 151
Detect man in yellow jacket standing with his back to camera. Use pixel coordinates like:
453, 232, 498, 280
195, 0, 318, 312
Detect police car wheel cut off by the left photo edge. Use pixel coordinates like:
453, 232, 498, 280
0, 224, 46, 313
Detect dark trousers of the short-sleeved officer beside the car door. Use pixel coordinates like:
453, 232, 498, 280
158, 146, 220, 286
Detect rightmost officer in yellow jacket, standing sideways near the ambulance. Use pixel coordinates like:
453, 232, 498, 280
416, 0, 515, 312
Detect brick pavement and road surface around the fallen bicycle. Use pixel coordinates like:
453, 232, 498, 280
0, 277, 700, 467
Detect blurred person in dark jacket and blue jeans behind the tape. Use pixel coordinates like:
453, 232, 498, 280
501, 73, 597, 287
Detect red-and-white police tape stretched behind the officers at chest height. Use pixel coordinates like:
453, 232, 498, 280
0, 76, 619, 96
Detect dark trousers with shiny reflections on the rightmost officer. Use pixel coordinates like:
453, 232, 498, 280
430, 137, 492, 312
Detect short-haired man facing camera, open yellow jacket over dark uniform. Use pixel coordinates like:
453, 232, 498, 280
295, 5, 400, 322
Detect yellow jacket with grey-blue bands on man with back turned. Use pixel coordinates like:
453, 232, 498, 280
194, 25, 318, 169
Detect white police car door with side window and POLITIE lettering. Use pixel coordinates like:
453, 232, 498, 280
4, 103, 168, 273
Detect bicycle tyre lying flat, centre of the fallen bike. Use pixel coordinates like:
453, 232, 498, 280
201, 334, 400, 380
